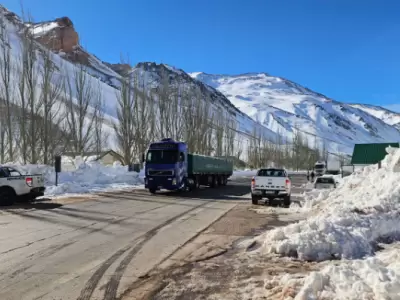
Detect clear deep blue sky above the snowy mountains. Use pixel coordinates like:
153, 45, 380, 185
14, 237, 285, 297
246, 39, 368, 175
2, 0, 400, 109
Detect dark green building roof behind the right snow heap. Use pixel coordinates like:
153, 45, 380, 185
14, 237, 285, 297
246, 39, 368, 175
351, 143, 400, 165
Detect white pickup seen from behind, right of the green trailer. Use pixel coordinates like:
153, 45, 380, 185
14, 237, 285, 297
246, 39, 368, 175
251, 168, 292, 207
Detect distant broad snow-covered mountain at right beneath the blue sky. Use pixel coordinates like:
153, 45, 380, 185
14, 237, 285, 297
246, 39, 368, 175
190, 72, 400, 153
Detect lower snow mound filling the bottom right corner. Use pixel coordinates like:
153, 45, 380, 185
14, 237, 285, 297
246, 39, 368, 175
264, 244, 400, 300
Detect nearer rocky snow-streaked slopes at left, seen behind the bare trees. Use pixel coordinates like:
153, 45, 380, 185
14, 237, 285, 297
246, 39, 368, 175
0, 6, 276, 162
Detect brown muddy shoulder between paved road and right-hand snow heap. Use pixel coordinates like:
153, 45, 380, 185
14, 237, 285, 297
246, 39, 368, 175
122, 203, 304, 300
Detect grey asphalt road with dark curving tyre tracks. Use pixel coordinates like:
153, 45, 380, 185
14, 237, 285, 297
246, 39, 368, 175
0, 176, 308, 300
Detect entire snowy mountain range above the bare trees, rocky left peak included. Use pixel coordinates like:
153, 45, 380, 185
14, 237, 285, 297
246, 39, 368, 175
0, 6, 400, 157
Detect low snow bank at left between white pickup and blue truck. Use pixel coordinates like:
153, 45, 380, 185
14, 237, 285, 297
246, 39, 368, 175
7, 157, 143, 196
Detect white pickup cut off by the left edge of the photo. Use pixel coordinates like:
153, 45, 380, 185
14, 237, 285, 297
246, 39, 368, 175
0, 166, 45, 206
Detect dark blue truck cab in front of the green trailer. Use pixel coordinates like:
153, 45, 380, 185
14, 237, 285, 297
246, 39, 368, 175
144, 138, 188, 193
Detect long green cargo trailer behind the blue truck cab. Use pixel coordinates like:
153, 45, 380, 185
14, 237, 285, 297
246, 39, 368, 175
188, 154, 233, 177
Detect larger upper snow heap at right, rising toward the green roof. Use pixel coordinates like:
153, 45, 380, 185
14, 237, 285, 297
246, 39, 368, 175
262, 148, 400, 260
